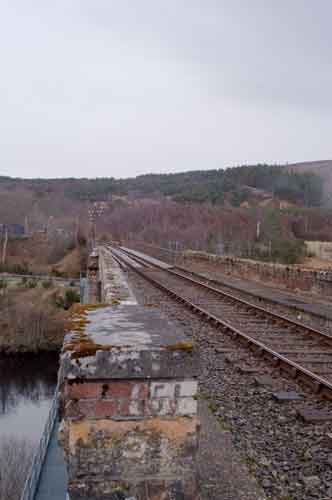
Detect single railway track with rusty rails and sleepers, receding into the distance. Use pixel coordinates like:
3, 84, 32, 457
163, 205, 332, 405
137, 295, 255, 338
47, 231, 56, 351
111, 245, 332, 399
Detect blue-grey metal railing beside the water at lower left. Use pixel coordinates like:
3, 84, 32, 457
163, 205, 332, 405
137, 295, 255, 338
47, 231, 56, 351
20, 385, 59, 500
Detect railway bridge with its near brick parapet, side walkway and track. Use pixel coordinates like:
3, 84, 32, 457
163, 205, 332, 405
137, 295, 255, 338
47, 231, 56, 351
22, 245, 332, 500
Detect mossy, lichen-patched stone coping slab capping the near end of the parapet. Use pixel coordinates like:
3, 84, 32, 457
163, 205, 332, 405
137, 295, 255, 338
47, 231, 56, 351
60, 302, 197, 379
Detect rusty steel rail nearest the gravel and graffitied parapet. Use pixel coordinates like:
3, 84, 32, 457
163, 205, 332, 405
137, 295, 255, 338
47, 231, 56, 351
112, 248, 332, 399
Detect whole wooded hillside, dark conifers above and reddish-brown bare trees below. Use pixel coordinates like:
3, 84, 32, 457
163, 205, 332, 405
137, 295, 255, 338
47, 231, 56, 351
0, 162, 332, 266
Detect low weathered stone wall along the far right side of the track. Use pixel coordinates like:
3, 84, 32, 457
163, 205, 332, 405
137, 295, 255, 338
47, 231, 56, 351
184, 251, 332, 297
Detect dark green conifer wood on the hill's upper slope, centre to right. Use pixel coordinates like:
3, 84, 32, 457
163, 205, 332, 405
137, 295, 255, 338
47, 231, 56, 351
115, 165, 323, 206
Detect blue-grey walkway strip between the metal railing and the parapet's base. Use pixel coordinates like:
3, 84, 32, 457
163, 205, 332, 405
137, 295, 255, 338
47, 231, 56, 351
35, 423, 67, 500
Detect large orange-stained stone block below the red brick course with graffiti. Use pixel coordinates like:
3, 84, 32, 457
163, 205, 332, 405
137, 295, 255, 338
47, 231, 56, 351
66, 417, 197, 481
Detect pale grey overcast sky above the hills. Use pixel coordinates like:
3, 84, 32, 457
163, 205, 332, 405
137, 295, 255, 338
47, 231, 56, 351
0, 0, 332, 177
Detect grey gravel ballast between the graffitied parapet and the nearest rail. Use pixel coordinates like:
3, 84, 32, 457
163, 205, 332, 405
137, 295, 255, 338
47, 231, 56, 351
129, 273, 332, 500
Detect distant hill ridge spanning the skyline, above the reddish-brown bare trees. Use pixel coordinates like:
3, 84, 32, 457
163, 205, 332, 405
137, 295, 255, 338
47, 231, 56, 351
0, 162, 326, 229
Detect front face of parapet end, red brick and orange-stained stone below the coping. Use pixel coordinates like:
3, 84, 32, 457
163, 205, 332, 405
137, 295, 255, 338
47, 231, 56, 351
62, 379, 197, 500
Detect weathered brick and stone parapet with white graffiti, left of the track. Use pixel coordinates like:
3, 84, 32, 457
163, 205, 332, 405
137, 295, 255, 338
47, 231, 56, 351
60, 252, 198, 500
